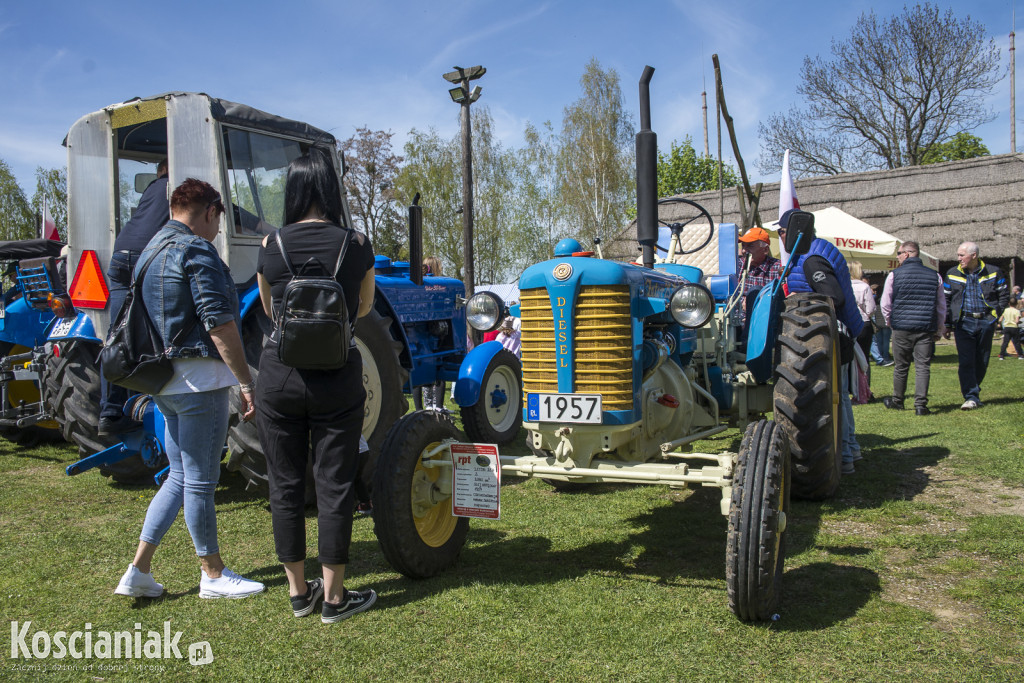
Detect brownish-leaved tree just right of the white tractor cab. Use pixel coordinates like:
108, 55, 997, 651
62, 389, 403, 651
340, 127, 406, 259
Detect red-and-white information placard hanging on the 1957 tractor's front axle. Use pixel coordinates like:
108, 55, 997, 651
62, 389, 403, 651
452, 443, 502, 519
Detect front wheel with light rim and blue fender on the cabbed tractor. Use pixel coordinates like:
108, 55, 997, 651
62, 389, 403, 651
460, 348, 522, 445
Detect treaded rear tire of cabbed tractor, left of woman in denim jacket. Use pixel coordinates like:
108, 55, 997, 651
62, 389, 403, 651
43, 341, 159, 483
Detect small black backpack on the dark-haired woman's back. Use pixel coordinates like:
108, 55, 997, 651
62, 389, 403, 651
273, 229, 352, 370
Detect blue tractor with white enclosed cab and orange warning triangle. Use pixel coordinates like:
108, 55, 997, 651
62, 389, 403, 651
35, 93, 521, 486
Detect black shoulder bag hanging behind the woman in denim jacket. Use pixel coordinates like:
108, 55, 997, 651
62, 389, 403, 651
99, 242, 195, 394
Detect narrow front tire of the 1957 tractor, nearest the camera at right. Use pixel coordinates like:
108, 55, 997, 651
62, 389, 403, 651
725, 420, 790, 622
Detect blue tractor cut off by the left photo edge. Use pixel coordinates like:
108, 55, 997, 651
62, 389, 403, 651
0, 240, 65, 445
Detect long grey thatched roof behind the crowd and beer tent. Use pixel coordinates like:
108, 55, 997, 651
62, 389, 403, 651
607, 154, 1024, 284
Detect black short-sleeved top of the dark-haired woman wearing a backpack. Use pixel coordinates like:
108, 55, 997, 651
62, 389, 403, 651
256, 221, 374, 321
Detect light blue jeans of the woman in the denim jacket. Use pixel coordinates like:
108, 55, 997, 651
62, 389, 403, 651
139, 387, 228, 557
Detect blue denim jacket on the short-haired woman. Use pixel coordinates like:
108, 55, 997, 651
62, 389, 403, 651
135, 220, 239, 358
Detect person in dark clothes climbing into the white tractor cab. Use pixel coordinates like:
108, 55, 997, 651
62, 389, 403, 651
96, 159, 170, 436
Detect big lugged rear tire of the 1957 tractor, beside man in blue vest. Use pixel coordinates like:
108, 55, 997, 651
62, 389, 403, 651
774, 293, 842, 500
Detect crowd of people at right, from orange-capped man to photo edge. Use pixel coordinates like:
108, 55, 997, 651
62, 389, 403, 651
738, 210, 1011, 474
